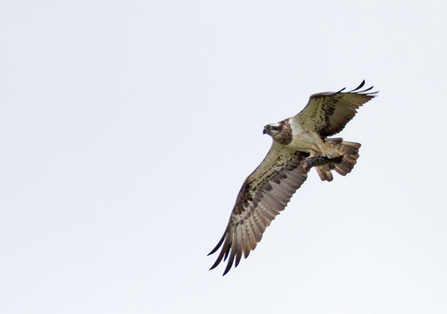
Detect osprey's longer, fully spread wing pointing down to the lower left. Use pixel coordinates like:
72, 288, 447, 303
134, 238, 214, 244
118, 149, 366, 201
208, 142, 310, 275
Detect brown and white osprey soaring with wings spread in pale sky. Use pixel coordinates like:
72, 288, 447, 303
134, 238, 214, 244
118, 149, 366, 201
208, 81, 378, 275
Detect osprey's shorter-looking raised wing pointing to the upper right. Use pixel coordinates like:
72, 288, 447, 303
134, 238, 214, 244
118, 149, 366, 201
294, 81, 377, 137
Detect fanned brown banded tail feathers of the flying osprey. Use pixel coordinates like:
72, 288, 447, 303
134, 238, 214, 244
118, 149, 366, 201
315, 138, 361, 182
